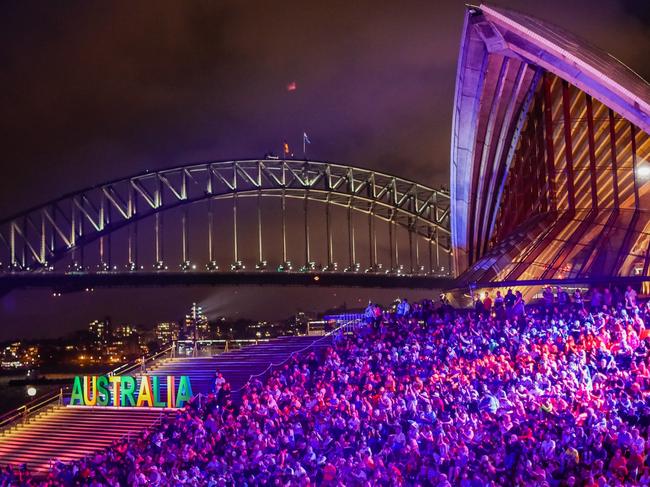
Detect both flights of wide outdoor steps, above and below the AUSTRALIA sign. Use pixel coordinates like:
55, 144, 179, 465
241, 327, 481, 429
0, 336, 330, 475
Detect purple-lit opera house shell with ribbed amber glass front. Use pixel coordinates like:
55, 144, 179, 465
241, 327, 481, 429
451, 5, 650, 282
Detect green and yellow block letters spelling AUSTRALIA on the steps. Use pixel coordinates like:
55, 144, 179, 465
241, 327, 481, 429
70, 375, 192, 408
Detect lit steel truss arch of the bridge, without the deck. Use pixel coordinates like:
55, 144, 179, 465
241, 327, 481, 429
0, 159, 451, 274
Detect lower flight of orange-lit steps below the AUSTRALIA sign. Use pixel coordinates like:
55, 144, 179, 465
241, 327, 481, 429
0, 406, 174, 475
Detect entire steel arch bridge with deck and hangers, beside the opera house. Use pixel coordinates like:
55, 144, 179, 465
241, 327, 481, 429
0, 159, 451, 294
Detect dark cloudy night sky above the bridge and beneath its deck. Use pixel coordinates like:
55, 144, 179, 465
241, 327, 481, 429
0, 0, 650, 339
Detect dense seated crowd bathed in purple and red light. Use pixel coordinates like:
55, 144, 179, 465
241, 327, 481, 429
5, 288, 650, 487
